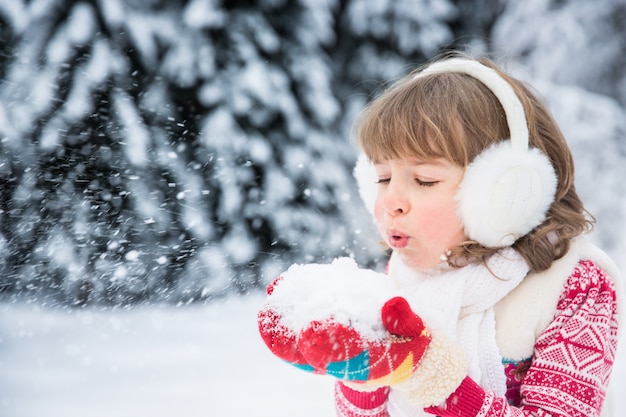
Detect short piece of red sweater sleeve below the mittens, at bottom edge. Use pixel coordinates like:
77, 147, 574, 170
335, 381, 389, 417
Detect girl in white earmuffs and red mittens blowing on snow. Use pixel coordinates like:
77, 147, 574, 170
259, 56, 623, 417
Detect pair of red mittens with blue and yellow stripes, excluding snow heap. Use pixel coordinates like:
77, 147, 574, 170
258, 268, 430, 385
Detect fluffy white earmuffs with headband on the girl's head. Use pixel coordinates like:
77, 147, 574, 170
354, 58, 557, 248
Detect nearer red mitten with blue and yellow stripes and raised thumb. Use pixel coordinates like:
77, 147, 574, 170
297, 297, 431, 386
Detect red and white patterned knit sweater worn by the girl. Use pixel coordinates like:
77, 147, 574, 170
335, 261, 618, 417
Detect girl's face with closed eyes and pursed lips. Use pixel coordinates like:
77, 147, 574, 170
374, 158, 466, 269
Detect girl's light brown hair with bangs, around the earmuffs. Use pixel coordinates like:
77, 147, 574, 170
355, 58, 594, 272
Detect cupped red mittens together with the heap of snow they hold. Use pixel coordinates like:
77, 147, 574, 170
258, 258, 431, 386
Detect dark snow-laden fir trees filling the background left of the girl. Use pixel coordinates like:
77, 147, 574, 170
0, 0, 454, 304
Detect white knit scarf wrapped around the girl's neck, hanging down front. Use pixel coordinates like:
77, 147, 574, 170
389, 248, 529, 416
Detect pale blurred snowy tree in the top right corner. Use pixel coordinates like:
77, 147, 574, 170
491, 0, 626, 106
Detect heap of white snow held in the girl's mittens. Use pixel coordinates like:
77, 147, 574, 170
263, 257, 397, 340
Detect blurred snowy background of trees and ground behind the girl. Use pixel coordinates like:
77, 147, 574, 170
0, 0, 626, 417
